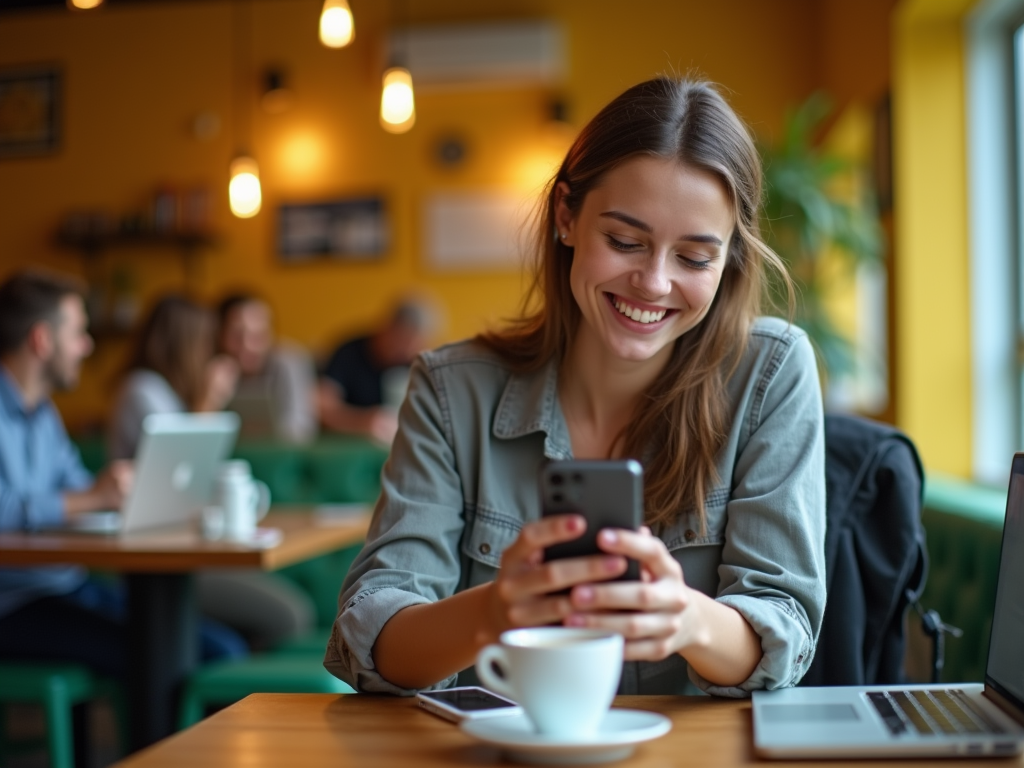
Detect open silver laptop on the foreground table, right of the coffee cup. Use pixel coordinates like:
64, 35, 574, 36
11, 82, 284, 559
754, 453, 1024, 758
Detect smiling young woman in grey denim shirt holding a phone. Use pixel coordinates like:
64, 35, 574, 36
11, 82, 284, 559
325, 78, 825, 695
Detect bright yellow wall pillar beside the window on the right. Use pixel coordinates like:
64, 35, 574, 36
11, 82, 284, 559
893, 0, 974, 477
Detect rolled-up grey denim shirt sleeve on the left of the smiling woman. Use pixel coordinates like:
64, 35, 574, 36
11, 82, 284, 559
324, 359, 464, 695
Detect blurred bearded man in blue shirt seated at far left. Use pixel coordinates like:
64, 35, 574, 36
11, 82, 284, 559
0, 271, 246, 679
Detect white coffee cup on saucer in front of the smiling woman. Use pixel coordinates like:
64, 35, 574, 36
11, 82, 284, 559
476, 627, 623, 740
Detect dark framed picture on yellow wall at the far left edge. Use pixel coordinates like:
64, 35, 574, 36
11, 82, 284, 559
0, 66, 61, 158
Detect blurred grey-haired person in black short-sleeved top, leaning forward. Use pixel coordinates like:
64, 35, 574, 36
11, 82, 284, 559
317, 297, 438, 444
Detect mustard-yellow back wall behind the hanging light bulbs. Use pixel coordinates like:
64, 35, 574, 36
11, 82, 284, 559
0, 0, 892, 434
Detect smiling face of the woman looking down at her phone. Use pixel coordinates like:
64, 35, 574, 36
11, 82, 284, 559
556, 156, 735, 362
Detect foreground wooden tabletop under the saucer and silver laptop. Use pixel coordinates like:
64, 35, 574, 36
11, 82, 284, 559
108, 693, 1024, 768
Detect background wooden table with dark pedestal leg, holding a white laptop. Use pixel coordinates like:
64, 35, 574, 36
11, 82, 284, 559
0, 508, 370, 749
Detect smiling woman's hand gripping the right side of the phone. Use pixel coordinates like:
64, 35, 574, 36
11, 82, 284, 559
564, 527, 707, 660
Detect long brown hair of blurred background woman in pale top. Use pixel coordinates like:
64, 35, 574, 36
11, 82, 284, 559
128, 296, 214, 411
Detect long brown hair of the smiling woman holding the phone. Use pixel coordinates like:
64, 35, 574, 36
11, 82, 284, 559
480, 77, 793, 527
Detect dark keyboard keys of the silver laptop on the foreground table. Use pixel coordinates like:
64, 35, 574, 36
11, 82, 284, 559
867, 688, 1004, 736
